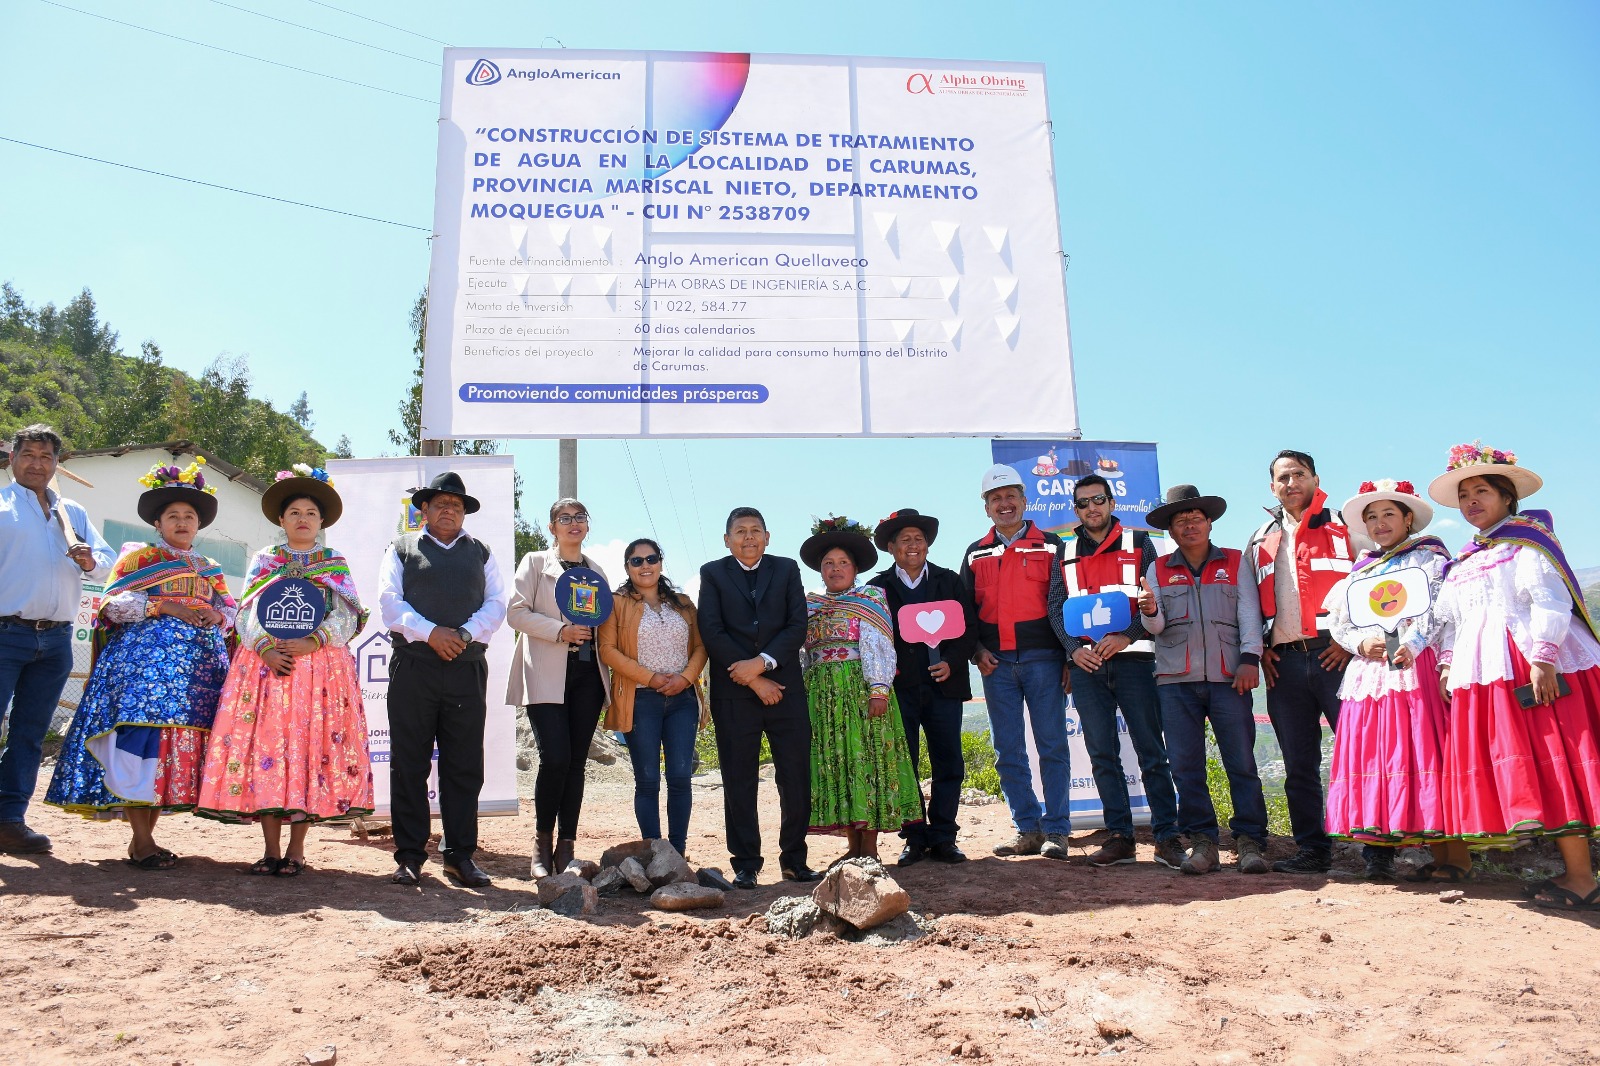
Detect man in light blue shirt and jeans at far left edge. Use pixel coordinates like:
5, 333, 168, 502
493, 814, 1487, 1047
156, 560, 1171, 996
0, 424, 115, 855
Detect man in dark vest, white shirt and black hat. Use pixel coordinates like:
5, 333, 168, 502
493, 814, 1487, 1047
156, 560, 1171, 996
378, 471, 507, 888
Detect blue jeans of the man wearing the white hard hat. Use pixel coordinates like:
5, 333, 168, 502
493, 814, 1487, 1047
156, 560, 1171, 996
984, 648, 1072, 832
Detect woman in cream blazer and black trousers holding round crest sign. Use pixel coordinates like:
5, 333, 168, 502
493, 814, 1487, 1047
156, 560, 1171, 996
506, 499, 610, 880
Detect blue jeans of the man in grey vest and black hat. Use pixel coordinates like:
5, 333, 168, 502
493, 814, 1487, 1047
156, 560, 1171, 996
1157, 682, 1267, 844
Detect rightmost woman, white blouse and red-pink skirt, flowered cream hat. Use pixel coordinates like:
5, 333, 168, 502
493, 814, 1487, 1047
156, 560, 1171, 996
1427, 442, 1600, 911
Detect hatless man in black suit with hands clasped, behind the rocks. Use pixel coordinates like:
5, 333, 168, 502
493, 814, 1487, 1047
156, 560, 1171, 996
699, 507, 819, 888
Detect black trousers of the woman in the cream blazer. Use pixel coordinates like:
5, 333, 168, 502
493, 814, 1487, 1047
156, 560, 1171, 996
528, 653, 604, 840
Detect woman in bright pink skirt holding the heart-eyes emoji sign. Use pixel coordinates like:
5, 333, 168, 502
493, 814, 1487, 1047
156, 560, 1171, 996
1328, 480, 1472, 882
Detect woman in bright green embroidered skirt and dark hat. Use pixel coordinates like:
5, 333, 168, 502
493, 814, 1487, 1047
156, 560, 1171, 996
800, 517, 922, 858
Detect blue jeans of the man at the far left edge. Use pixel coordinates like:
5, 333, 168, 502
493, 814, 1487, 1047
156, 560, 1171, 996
0, 623, 72, 821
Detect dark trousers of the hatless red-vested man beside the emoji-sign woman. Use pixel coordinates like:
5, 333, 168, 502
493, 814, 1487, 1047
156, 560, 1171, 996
1267, 645, 1344, 852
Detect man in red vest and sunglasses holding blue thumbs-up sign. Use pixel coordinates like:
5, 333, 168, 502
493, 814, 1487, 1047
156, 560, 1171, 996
1050, 474, 1184, 869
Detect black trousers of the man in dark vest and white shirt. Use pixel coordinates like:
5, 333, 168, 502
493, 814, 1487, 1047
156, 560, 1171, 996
389, 645, 490, 866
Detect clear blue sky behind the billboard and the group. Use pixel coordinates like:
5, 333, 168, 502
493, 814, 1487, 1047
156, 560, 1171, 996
0, 0, 1600, 578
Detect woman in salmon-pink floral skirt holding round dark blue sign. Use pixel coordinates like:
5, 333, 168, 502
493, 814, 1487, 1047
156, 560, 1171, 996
195, 464, 373, 877
